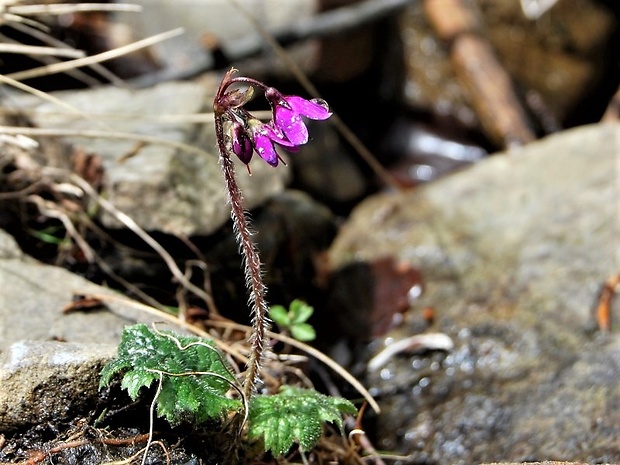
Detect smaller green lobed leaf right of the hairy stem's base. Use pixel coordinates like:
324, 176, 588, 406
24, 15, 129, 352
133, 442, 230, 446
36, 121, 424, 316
248, 386, 357, 456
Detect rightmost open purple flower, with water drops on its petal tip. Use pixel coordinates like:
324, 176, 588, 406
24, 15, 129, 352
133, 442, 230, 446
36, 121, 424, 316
265, 87, 331, 146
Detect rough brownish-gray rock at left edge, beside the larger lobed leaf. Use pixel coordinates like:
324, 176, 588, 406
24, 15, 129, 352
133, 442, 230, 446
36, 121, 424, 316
0, 341, 116, 432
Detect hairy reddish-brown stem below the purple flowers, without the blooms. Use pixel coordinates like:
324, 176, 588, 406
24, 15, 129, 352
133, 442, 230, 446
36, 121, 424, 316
215, 113, 269, 401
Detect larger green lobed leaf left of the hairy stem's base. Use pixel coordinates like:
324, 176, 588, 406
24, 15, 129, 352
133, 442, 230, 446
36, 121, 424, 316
99, 324, 241, 425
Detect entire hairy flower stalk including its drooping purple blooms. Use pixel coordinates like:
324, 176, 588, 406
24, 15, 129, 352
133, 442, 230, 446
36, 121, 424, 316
213, 69, 331, 400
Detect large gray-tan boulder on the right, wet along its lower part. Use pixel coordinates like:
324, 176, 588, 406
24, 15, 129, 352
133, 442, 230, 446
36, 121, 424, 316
330, 124, 620, 463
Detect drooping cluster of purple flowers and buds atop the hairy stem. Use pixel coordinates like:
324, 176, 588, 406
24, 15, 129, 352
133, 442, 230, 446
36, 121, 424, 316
213, 69, 331, 170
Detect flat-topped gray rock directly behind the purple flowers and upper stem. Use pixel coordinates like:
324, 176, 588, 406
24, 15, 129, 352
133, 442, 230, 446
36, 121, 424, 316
14, 75, 290, 235
